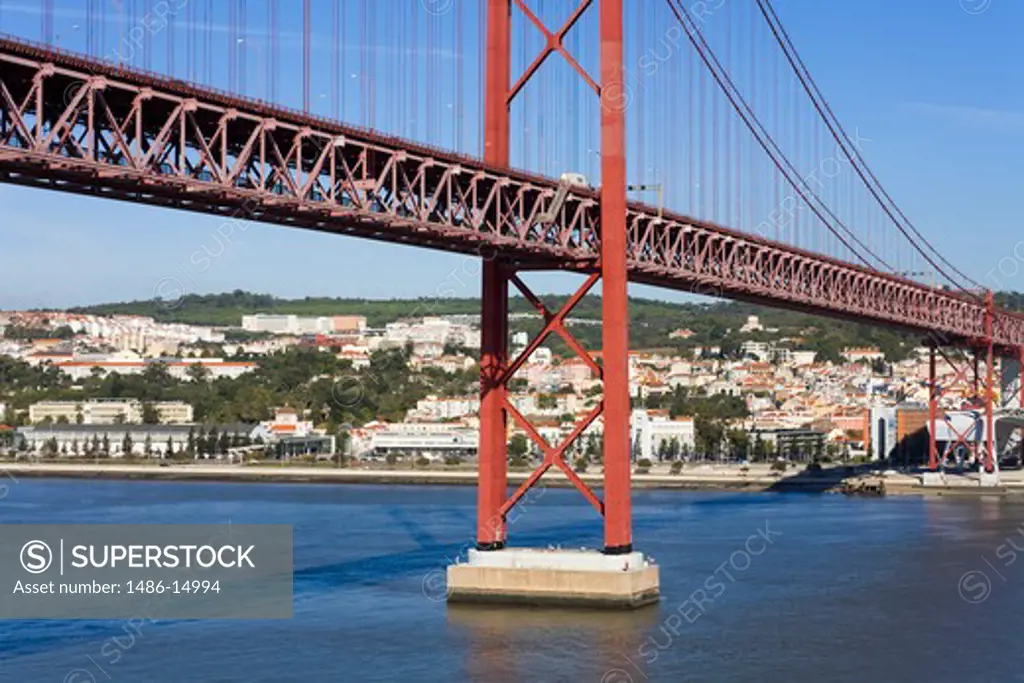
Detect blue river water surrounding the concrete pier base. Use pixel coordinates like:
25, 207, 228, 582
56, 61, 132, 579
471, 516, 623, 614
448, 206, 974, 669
0, 480, 1024, 683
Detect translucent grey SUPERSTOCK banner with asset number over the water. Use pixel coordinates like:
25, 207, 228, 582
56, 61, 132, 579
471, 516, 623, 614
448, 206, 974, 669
0, 524, 293, 620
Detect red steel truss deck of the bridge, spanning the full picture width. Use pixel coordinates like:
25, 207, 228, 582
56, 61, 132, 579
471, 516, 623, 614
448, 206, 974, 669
0, 34, 1024, 352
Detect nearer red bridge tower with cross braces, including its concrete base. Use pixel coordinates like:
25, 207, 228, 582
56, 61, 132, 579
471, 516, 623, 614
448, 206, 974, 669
449, 0, 657, 606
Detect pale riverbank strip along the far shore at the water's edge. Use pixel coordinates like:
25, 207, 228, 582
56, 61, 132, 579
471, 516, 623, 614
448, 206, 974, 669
0, 462, 1024, 496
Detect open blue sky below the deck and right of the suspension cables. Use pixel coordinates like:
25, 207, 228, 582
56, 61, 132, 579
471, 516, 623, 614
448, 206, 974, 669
0, 0, 1024, 308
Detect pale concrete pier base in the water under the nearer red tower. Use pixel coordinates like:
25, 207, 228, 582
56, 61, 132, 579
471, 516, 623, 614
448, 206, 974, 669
447, 548, 658, 609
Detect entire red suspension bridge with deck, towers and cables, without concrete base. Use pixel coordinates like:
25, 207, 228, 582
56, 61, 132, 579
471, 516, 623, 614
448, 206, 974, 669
0, 0, 1024, 565
